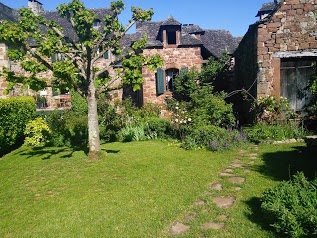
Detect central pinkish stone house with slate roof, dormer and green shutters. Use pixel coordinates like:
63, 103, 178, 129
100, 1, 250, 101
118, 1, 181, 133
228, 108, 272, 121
119, 16, 238, 105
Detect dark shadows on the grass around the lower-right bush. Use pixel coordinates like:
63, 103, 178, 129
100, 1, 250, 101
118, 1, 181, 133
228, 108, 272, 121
246, 146, 317, 235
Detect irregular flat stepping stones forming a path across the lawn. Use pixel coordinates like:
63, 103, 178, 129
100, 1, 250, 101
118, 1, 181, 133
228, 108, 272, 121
168, 145, 259, 234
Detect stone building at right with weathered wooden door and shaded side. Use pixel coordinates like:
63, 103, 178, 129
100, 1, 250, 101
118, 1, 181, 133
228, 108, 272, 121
234, 0, 317, 122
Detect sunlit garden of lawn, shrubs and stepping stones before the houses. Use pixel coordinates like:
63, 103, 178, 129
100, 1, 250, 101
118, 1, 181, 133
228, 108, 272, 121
0, 56, 317, 237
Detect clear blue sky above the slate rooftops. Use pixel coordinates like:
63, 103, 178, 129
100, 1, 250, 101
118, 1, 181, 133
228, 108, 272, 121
0, 0, 273, 36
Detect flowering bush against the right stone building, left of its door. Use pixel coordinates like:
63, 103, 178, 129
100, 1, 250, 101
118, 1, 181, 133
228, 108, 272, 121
254, 96, 295, 123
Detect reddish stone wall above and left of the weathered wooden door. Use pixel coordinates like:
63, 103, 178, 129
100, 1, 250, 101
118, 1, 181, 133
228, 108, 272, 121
257, 0, 317, 97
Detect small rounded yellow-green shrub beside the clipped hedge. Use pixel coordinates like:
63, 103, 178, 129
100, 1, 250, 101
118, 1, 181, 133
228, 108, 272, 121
24, 117, 51, 146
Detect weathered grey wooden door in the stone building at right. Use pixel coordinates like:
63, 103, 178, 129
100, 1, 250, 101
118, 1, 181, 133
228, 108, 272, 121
280, 58, 316, 111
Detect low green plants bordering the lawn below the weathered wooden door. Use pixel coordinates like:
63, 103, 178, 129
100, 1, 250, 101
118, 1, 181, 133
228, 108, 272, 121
243, 122, 307, 143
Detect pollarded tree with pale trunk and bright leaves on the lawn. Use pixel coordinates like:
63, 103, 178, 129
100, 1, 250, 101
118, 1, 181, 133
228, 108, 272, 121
0, 0, 162, 159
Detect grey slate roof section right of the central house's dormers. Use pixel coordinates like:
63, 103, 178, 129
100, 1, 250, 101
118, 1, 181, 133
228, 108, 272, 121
201, 30, 240, 57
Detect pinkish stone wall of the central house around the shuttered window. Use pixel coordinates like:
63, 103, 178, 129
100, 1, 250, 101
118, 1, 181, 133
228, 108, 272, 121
142, 46, 202, 106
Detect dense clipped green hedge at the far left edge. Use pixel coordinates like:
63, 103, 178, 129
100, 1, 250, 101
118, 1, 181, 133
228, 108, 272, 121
0, 97, 36, 154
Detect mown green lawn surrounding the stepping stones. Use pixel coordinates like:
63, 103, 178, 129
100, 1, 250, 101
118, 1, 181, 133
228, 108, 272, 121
0, 141, 317, 238
